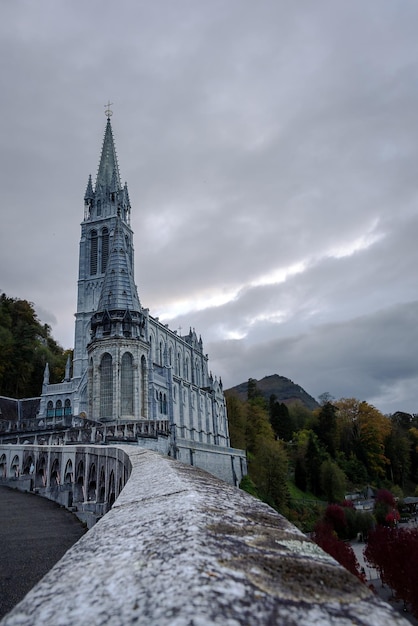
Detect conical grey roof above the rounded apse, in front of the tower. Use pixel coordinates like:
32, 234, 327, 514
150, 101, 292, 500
97, 214, 141, 312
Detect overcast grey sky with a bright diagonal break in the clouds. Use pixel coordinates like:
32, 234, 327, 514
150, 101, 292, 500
0, 0, 418, 412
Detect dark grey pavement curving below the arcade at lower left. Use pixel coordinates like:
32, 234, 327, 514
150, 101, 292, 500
0, 486, 86, 619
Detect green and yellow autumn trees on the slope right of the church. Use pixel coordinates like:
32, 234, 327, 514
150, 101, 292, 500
227, 379, 418, 530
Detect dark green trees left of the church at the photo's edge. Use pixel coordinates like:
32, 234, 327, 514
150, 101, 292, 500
0, 293, 69, 398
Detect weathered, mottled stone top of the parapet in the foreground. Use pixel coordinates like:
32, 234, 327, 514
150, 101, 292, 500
1, 447, 408, 626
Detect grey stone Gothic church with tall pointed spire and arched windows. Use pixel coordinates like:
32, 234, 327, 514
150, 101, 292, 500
39, 110, 246, 483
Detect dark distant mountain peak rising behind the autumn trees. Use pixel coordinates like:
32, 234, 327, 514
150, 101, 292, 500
225, 374, 319, 411
